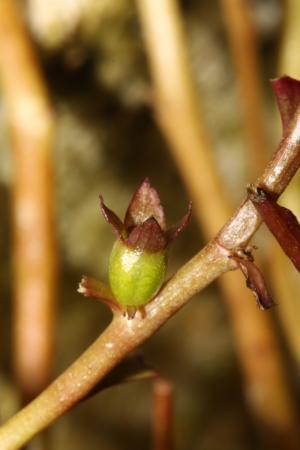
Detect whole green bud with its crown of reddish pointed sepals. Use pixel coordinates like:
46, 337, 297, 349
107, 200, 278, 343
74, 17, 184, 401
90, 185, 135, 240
100, 179, 191, 315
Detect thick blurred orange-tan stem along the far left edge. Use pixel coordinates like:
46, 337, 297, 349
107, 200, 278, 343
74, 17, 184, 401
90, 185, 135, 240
0, 0, 56, 399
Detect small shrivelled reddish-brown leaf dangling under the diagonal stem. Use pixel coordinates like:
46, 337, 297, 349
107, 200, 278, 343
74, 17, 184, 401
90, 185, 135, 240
232, 256, 275, 309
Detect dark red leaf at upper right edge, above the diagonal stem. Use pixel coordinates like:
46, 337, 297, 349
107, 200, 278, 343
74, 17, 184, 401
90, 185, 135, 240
271, 76, 300, 137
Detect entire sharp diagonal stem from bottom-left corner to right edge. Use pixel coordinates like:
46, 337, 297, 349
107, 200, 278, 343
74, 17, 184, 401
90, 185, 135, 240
0, 85, 300, 450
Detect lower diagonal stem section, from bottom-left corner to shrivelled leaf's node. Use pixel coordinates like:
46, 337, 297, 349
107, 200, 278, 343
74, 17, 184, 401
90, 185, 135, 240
0, 243, 232, 450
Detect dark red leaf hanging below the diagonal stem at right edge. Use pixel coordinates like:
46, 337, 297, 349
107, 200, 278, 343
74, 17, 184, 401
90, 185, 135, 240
250, 188, 300, 272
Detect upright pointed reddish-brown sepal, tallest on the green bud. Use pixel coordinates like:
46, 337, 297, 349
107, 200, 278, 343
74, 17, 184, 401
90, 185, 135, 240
124, 178, 166, 230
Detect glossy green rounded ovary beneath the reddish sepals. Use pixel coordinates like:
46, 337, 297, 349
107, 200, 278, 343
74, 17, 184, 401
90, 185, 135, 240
109, 241, 167, 308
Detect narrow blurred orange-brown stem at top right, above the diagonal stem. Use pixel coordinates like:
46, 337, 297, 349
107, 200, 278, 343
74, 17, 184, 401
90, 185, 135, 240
220, 0, 267, 176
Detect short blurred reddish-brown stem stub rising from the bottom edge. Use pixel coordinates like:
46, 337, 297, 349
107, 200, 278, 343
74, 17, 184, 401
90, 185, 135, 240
152, 378, 173, 450
